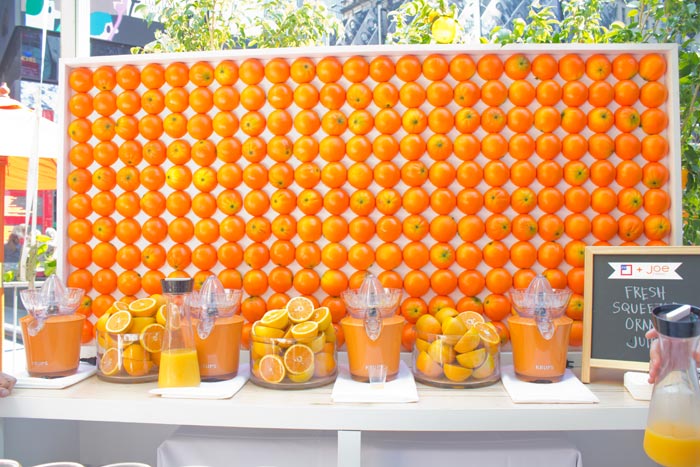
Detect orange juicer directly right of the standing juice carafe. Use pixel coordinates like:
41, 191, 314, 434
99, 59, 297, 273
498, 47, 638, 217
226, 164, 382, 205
191, 276, 243, 381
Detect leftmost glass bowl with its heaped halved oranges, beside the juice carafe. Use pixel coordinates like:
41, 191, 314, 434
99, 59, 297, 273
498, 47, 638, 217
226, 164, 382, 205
95, 294, 165, 383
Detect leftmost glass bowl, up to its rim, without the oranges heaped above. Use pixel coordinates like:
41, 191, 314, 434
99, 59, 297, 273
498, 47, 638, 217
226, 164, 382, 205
95, 331, 160, 383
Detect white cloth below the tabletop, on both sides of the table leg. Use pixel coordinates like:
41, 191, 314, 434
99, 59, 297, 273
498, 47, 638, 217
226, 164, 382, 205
158, 427, 582, 467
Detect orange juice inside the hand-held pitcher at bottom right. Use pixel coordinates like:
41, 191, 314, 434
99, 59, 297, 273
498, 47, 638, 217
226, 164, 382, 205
644, 422, 700, 467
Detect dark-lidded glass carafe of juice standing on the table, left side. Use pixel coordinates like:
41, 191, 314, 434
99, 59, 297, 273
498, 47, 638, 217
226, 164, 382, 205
158, 278, 200, 388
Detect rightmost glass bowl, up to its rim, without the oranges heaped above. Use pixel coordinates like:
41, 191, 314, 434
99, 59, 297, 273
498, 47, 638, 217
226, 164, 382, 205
413, 325, 501, 389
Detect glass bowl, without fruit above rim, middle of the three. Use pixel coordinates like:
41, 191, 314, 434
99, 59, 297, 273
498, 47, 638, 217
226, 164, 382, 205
250, 333, 338, 389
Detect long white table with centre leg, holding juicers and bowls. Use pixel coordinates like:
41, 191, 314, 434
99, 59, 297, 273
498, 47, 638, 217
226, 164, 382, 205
0, 354, 648, 467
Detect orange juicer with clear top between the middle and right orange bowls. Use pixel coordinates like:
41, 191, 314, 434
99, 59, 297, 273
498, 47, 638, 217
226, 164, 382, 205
340, 273, 404, 382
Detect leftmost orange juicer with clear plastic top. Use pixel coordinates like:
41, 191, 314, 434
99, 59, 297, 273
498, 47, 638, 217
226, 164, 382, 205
20, 275, 85, 378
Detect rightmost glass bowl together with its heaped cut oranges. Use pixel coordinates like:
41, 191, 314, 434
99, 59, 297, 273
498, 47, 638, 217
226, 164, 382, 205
413, 308, 501, 388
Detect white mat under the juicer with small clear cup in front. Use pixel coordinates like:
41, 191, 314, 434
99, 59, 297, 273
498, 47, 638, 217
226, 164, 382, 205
331, 361, 418, 403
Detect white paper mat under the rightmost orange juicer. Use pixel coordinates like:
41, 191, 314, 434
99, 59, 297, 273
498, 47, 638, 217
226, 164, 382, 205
501, 365, 600, 404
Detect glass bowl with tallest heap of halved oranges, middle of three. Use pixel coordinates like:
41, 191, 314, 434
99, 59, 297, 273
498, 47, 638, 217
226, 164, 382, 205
250, 297, 338, 389
